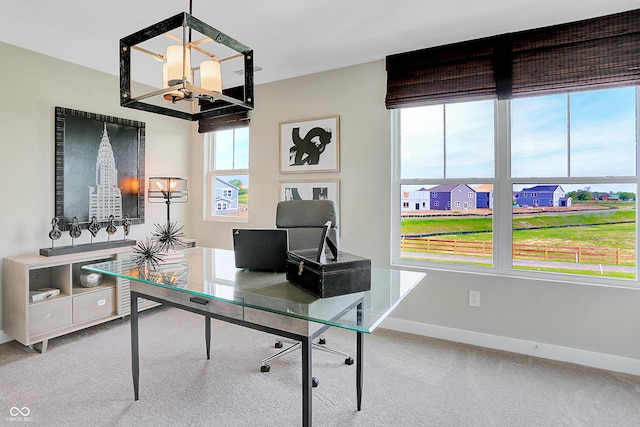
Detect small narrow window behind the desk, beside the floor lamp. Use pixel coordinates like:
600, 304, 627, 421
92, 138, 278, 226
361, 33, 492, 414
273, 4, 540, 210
205, 127, 249, 221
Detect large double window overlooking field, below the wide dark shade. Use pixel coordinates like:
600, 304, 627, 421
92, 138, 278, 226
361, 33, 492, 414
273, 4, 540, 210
392, 87, 639, 282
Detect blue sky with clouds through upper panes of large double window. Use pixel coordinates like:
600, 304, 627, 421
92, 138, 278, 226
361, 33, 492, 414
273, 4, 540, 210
401, 87, 637, 192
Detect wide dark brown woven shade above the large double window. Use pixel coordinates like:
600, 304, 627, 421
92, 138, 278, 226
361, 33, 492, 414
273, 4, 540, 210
386, 9, 640, 109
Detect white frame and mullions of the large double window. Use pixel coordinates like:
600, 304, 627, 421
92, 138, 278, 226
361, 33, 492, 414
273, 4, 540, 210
390, 90, 640, 288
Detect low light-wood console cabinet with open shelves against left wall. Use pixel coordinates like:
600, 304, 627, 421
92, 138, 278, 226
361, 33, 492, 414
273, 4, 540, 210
2, 247, 157, 352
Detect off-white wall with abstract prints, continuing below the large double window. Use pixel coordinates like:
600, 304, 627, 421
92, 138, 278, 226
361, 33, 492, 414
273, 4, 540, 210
191, 61, 640, 374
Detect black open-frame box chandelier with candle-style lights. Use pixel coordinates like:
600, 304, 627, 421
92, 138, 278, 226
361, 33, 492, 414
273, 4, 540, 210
120, 2, 253, 121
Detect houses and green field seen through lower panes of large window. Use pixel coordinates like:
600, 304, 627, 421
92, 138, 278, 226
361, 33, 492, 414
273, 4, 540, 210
401, 184, 636, 277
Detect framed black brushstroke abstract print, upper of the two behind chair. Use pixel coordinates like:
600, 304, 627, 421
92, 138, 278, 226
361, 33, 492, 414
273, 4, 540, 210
280, 115, 340, 173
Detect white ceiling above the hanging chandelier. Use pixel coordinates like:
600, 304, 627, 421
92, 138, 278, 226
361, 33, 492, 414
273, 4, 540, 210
0, 0, 638, 86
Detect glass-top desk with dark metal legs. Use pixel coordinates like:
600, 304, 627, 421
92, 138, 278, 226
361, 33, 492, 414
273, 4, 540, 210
83, 247, 425, 426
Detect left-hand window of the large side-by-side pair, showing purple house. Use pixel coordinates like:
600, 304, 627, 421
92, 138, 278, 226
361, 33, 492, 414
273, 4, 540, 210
394, 101, 495, 266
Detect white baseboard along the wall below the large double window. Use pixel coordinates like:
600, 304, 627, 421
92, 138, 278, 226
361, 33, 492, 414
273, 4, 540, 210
381, 318, 640, 375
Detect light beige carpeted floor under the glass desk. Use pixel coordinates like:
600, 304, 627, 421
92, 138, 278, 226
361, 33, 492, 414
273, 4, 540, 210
0, 308, 640, 427
